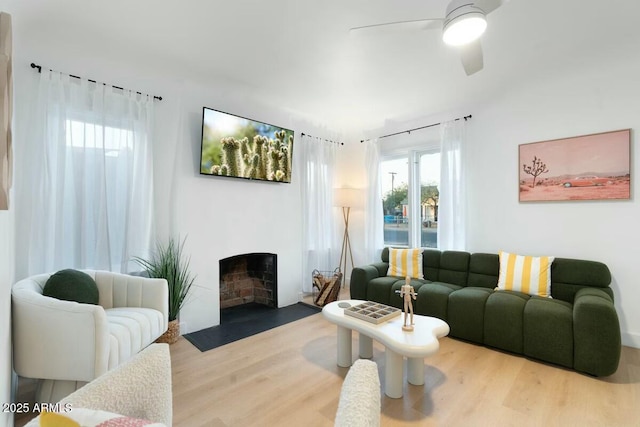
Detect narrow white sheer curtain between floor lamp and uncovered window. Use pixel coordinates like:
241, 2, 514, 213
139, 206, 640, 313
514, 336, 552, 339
364, 139, 384, 263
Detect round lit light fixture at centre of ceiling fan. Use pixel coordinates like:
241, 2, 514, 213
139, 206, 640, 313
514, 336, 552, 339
442, 1, 487, 46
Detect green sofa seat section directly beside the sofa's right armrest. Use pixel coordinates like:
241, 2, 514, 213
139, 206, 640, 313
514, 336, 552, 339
523, 296, 573, 368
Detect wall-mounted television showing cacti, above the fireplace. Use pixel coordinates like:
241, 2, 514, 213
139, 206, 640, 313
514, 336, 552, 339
200, 107, 293, 182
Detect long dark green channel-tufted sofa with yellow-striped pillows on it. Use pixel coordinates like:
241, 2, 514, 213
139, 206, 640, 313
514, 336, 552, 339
350, 248, 621, 376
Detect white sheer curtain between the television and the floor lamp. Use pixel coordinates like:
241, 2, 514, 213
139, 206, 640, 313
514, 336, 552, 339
300, 135, 340, 292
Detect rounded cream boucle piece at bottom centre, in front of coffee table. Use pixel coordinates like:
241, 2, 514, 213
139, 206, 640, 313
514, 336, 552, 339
335, 359, 380, 427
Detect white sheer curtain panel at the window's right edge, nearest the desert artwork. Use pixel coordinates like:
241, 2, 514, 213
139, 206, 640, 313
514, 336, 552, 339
438, 120, 466, 250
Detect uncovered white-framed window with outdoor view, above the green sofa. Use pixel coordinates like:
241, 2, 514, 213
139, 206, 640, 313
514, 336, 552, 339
380, 150, 440, 248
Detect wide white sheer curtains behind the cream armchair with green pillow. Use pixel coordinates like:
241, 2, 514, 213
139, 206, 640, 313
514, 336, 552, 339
15, 69, 153, 277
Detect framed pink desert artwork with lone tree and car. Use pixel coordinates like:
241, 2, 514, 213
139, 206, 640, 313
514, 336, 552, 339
518, 129, 631, 202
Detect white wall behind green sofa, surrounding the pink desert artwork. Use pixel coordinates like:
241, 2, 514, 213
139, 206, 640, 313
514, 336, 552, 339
467, 55, 640, 347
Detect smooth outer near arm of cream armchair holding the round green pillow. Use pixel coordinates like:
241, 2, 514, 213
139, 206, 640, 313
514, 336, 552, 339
11, 288, 109, 381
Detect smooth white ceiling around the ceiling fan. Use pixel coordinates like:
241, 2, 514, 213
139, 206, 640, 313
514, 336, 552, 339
0, 0, 640, 132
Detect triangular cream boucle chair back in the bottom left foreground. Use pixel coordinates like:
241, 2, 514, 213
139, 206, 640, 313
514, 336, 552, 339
26, 344, 173, 427
